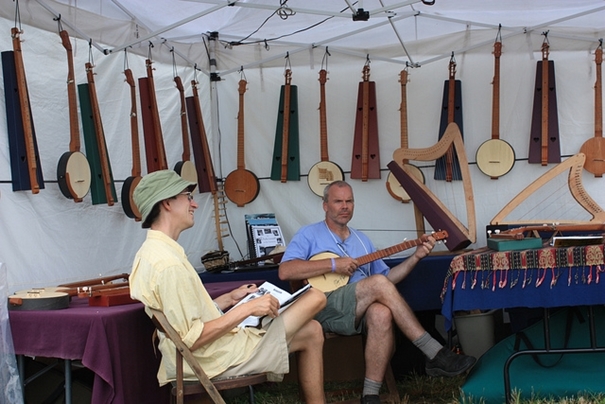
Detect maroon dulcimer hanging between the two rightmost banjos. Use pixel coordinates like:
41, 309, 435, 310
527, 40, 561, 166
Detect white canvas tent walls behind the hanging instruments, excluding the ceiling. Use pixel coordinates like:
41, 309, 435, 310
0, 14, 605, 290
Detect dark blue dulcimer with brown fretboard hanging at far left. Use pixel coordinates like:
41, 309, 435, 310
2, 27, 44, 194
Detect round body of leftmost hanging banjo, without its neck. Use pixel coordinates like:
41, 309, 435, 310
57, 151, 91, 202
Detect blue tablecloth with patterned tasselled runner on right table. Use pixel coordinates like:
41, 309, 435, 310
441, 244, 605, 330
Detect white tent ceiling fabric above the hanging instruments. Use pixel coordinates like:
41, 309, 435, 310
0, 0, 605, 74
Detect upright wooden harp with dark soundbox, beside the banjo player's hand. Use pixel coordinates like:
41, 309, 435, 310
387, 123, 477, 251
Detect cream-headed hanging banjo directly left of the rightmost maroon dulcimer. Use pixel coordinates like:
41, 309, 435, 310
475, 41, 515, 180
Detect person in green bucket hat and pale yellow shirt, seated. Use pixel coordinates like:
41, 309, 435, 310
130, 170, 326, 403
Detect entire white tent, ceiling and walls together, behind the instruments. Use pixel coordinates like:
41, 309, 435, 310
0, 0, 605, 290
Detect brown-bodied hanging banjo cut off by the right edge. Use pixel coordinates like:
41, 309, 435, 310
580, 43, 605, 178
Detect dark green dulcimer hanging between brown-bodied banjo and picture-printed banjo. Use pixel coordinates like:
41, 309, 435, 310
271, 69, 300, 182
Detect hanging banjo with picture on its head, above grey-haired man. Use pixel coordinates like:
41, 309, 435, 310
307, 69, 344, 197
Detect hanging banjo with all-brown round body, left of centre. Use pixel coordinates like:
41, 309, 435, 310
224, 79, 260, 207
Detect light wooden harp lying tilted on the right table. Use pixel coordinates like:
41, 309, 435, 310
490, 153, 605, 225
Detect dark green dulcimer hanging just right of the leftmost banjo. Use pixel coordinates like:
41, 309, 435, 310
78, 62, 118, 206
